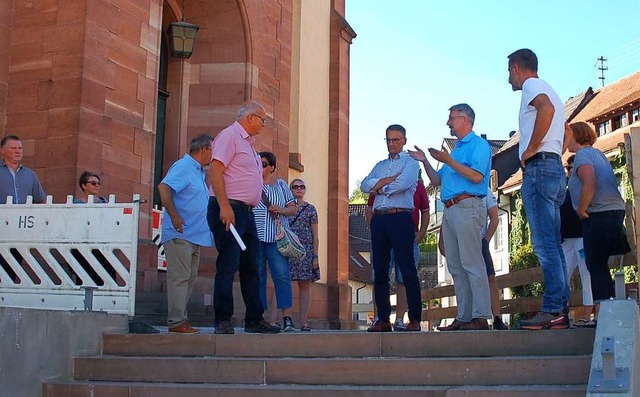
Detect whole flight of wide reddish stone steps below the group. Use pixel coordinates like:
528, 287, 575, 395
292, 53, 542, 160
43, 329, 595, 397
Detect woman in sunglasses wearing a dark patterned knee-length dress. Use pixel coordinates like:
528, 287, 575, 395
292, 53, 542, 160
289, 179, 320, 331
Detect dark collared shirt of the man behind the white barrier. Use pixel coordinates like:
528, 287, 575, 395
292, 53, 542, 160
0, 160, 47, 204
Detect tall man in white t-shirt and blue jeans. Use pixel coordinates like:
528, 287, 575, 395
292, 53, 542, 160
508, 49, 569, 329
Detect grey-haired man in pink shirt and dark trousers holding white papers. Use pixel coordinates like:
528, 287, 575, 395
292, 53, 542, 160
207, 101, 280, 334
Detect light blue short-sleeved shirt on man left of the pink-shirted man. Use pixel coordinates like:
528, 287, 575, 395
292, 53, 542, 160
161, 154, 213, 247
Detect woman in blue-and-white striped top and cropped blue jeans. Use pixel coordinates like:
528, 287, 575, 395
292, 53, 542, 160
253, 152, 297, 332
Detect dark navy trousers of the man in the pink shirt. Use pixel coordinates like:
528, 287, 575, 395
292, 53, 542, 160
207, 198, 264, 326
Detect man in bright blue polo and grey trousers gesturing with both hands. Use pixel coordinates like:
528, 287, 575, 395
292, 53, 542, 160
409, 103, 492, 331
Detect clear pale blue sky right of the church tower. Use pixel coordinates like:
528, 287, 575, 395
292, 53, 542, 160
346, 0, 640, 192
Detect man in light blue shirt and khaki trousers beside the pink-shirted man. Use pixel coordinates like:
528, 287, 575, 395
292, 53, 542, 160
158, 135, 213, 334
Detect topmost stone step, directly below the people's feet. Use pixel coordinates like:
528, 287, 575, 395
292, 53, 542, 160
103, 329, 595, 357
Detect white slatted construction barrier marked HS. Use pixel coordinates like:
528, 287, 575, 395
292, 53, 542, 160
0, 194, 140, 315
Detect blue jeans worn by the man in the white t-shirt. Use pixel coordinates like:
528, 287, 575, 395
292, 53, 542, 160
522, 157, 569, 313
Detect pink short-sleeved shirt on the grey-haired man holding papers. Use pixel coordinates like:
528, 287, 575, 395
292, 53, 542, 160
209, 121, 262, 206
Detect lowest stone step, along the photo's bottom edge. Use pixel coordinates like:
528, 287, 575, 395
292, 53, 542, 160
43, 381, 586, 397
